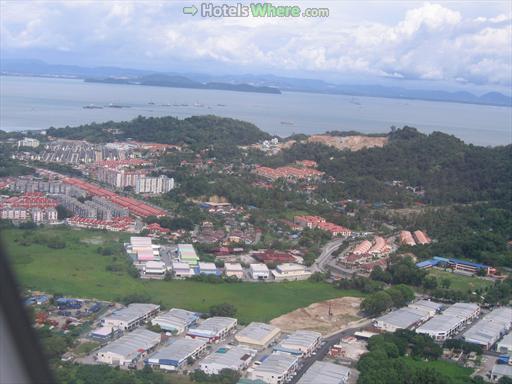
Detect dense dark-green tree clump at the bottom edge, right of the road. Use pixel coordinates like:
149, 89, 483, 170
357, 330, 481, 384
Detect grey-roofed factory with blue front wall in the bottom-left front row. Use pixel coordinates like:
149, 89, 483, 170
144, 339, 207, 371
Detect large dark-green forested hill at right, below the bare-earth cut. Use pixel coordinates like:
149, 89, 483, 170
274, 127, 512, 204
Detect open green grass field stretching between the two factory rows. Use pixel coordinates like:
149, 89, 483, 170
2, 228, 362, 322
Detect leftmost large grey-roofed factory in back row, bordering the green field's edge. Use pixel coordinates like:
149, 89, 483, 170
103, 303, 160, 331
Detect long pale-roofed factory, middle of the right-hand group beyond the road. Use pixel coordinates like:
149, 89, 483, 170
416, 303, 480, 341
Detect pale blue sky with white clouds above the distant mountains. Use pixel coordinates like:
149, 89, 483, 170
0, 0, 512, 93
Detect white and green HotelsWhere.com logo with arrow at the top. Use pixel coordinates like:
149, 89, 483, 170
183, 3, 329, 18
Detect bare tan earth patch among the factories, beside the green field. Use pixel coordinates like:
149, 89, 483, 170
270, 297, 362, 335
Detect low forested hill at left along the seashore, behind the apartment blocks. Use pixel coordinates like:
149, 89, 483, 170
48, 115, 271, 149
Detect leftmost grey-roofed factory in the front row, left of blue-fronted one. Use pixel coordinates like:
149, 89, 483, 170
96, 329, 160, 366
